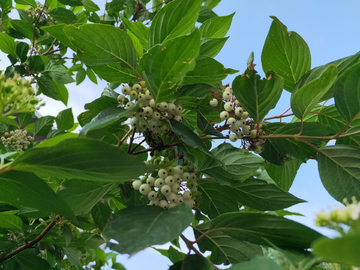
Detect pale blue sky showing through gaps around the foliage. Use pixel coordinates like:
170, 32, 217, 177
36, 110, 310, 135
0, 0, 360, 270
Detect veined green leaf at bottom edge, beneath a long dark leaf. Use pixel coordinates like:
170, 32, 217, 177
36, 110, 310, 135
193, 222, 263, 265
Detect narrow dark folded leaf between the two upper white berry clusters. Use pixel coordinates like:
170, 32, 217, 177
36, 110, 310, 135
170, 120, 209, 152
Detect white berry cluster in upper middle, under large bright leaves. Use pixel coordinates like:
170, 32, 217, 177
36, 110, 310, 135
118, 81, 182, 133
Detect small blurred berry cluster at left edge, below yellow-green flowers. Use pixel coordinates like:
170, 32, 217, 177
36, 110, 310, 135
1, 129, 34, 151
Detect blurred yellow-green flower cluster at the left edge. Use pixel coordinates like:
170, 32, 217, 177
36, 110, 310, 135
0, 73, 43, 116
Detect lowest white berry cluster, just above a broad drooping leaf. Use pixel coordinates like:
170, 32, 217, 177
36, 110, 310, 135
132, 166, 200, 209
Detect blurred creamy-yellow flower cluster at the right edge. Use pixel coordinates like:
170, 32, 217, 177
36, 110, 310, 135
315, 197, 360, 227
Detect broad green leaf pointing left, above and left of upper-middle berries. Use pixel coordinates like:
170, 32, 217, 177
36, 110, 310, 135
64, 24, 137, 69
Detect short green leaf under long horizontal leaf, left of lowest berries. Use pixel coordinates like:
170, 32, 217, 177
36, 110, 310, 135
57, 179, 113, 215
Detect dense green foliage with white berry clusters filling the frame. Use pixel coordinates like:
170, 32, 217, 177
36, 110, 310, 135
0, 0, 360, 270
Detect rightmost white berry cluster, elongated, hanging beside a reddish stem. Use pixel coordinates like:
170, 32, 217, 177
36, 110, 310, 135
210, 86, 265, 153
